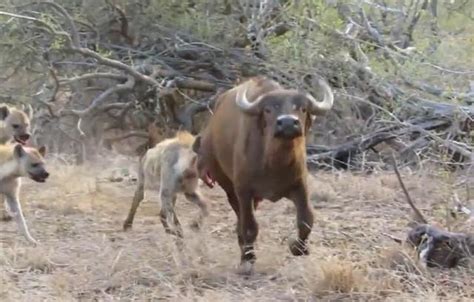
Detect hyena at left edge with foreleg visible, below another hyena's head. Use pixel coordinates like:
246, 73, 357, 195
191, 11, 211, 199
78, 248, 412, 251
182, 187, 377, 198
0, 144, 49, 245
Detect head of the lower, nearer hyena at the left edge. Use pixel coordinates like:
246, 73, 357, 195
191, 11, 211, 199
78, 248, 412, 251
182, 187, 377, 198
13, 144, 49, 182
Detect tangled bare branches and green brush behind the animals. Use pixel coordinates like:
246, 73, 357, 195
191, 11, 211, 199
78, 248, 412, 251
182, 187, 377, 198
0, 0, 474, 168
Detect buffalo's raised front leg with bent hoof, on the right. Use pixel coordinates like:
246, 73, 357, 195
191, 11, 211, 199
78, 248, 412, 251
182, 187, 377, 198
288, 184, 314, 256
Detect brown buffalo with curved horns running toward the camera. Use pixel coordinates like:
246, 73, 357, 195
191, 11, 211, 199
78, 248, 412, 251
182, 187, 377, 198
193, 76, 334, 274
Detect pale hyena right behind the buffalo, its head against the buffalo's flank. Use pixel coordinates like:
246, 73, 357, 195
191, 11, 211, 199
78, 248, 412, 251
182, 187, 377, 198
123, 128, 209, 237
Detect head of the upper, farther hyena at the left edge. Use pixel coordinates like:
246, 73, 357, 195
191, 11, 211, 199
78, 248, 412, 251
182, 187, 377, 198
0, 105, 31, 144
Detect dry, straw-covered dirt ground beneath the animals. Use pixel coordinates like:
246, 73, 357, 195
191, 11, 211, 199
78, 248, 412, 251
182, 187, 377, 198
0, 157, 474, 302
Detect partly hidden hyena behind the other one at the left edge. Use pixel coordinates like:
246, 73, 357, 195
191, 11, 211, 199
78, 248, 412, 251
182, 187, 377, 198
0, 104, 31, 145
